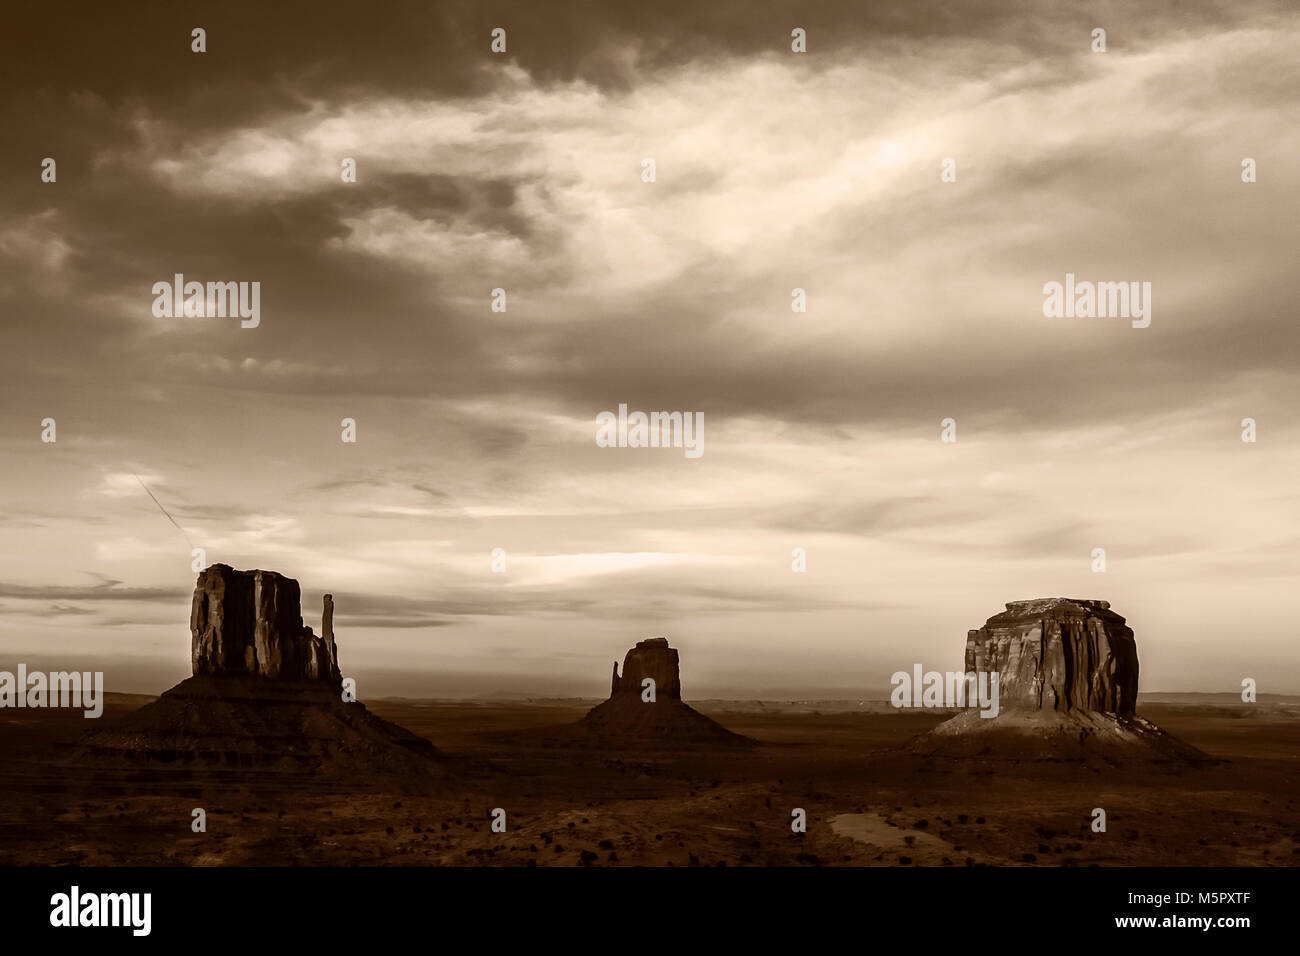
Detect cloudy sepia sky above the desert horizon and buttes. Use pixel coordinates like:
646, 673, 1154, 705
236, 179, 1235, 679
0, 0, 1300, 698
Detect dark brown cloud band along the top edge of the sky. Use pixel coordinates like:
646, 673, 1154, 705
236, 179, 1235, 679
0, 0, 1268, 102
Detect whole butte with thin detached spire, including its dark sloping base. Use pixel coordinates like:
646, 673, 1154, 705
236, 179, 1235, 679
74, 564, 443, 786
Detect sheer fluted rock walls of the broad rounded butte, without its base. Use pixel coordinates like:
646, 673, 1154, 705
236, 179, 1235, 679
966, 597, 1138, 717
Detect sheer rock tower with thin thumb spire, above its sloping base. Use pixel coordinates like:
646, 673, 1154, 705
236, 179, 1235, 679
190, 564, 342, 685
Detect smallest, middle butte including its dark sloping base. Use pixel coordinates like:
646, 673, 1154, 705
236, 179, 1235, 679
579, 637, 754, 749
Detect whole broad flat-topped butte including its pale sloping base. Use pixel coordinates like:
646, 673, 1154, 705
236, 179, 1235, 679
907, 597, 1213, 763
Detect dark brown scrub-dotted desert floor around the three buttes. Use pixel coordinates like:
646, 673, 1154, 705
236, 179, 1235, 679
0, 697, 1300, 866
